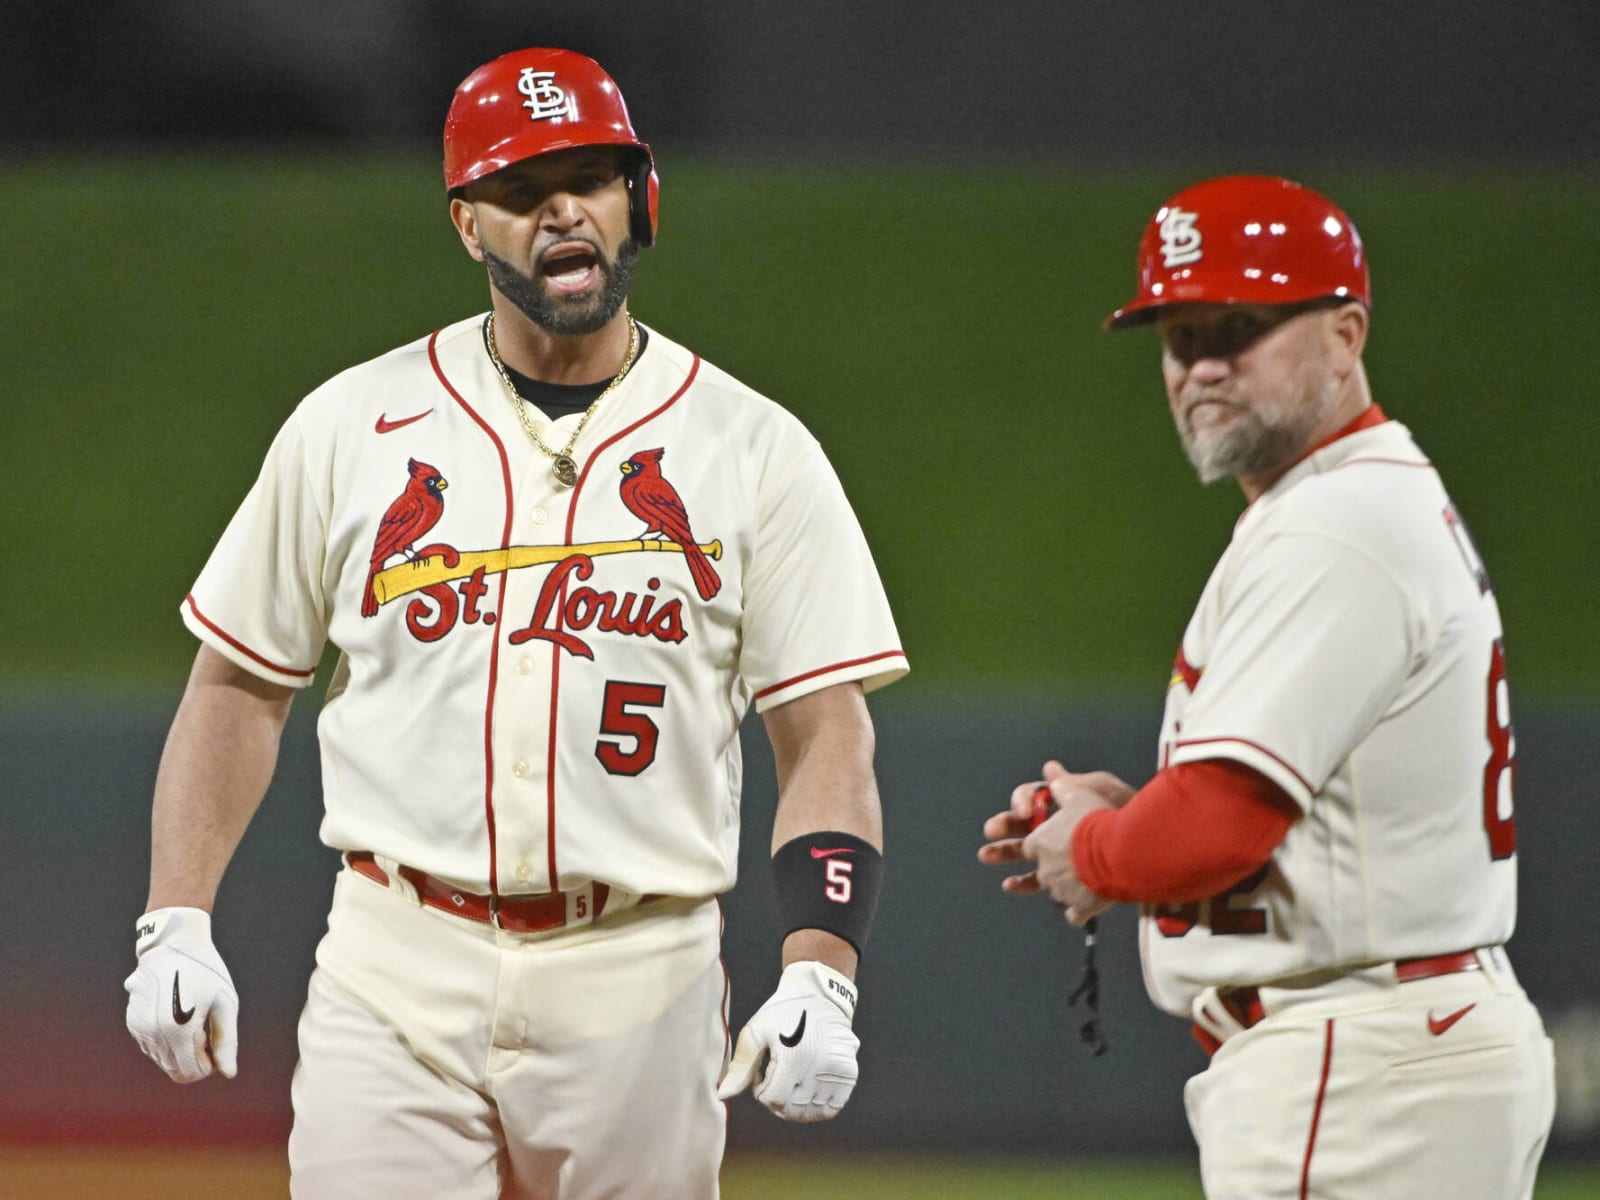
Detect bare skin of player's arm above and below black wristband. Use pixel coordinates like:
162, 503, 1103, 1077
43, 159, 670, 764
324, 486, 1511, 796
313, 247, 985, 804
766, 683, 883, 978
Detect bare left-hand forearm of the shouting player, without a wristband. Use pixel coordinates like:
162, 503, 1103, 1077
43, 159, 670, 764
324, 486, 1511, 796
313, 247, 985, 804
146, 646, 294, 912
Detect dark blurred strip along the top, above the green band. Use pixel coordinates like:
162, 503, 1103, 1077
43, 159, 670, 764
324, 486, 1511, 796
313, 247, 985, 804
0, 0, 1600, 166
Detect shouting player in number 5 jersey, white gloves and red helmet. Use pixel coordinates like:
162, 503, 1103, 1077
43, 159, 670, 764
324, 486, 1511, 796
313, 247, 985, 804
126, 50, 907, 1200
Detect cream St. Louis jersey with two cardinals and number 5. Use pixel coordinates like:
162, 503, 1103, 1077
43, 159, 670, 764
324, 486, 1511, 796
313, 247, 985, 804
182, 317, 907, 896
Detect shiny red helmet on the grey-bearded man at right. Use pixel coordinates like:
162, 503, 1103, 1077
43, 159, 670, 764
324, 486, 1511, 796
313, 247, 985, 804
1106, 174, 1371, 330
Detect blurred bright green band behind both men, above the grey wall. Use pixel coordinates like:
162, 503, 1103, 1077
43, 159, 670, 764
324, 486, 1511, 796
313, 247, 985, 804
0, 155, 1600, 701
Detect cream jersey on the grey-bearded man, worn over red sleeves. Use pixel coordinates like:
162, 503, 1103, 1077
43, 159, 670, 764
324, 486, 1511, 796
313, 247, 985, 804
1141, 421, 1517, 1016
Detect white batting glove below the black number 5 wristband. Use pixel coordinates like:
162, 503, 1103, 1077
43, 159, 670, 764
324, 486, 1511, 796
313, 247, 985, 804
717, 960, 861, 1122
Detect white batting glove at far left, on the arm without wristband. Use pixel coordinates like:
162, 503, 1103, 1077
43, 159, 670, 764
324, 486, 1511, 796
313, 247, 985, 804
123, 909, 238, 1083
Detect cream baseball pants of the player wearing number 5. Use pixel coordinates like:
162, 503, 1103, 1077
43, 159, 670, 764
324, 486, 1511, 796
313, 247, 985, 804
290, 869, 728, 1200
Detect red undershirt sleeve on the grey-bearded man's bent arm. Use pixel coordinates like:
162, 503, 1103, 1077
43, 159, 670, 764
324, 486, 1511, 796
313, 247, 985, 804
1072, 758, 1301, 904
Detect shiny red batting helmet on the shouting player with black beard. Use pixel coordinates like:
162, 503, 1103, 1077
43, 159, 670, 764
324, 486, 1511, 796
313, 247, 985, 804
445, 48, 661, 246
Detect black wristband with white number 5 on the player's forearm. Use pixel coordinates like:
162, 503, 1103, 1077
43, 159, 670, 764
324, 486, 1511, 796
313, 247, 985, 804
773, 830, 883, 954
